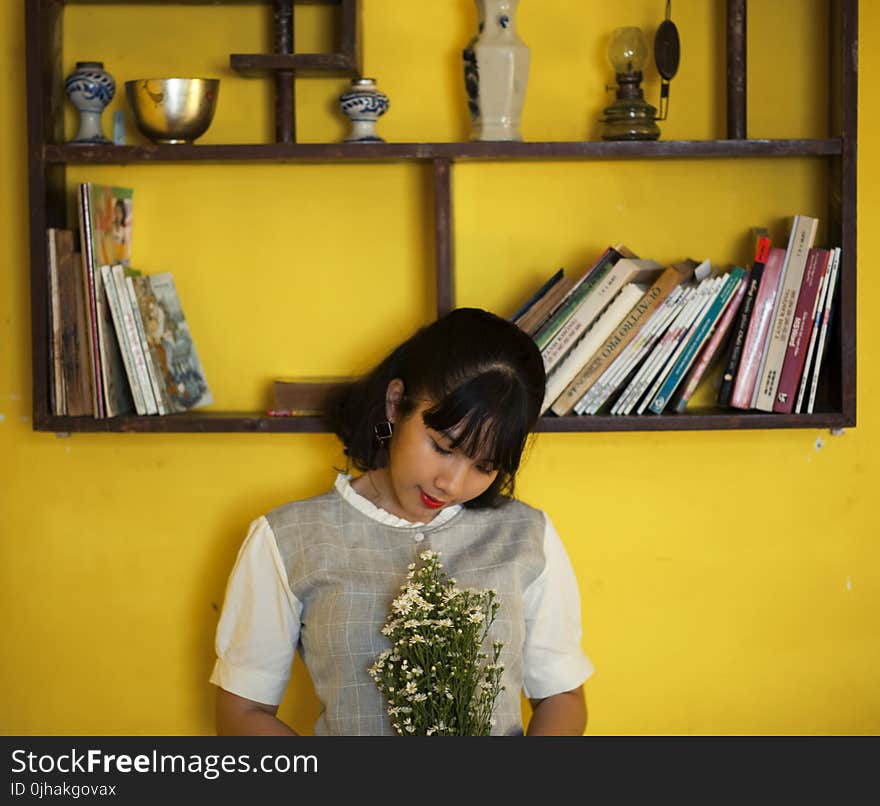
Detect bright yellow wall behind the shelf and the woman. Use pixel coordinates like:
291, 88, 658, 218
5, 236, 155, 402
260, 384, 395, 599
0, 0, 880, 734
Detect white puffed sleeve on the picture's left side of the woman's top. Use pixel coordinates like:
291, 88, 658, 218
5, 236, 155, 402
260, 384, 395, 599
210, 517, 302, 705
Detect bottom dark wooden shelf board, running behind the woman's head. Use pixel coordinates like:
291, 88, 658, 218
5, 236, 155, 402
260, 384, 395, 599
34, 409, 855, 434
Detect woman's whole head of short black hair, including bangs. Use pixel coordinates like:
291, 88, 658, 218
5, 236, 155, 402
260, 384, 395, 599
325, 308, 546, 508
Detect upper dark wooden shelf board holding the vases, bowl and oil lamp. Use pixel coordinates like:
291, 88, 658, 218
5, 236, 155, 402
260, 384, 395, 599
42, 137, 843, 164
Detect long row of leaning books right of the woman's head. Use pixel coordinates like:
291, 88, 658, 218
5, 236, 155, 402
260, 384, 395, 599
511, 216, 840, 416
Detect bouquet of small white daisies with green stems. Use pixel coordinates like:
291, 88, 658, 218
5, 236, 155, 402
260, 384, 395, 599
370, 551, 504, 736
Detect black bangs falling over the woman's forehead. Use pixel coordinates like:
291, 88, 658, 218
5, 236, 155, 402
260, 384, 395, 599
422, 370, 532, 476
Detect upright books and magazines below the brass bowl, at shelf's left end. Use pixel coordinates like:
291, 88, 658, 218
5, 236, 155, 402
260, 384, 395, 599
47, 183, 212, 417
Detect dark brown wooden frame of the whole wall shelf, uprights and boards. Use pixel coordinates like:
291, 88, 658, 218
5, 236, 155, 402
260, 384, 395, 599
26, 0, 859, 433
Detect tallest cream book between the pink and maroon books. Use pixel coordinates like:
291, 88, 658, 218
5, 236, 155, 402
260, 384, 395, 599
754, 216, 818, 411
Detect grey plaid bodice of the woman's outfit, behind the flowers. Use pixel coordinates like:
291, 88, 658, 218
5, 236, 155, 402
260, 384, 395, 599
266, 489, 544, 736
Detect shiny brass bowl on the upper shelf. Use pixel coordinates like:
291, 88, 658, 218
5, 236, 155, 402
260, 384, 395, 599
125, 78, 220, 143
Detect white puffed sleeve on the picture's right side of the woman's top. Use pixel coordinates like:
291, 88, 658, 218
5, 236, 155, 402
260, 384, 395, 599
523, 514, 593, 699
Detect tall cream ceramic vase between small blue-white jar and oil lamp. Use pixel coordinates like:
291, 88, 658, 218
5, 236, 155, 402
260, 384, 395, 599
462, 0, 530, 140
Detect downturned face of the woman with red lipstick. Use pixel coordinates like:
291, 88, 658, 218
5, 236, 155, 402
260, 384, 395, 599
387, 401, 498, 522
